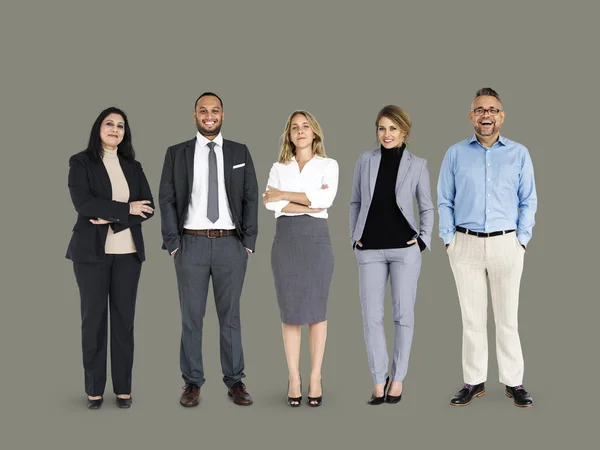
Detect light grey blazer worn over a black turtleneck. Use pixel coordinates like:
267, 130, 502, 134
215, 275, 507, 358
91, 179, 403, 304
350, 149, 434, 250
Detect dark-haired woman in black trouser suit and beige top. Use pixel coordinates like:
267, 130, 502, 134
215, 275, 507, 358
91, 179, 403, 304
66, 107, 154, 409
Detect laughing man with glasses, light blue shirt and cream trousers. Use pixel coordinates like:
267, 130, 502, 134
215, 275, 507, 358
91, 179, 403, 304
438, 88, 537, 407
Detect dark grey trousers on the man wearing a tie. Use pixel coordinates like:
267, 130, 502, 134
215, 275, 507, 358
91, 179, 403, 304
174, 234, 248, 387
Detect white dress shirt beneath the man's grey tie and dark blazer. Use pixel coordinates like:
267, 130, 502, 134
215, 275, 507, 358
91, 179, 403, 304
183, 132, 235, 230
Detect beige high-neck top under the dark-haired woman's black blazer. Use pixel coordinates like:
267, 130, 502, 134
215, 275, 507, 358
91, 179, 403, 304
102, 149, 137, 255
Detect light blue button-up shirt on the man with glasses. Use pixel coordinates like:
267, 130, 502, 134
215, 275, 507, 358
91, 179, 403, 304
437, 135, 537, 246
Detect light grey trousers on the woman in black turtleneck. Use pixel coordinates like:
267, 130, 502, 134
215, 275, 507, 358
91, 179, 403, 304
355, 244, 421, 384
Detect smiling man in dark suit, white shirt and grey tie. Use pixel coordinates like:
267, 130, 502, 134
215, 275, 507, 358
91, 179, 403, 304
159, 92, 258, 407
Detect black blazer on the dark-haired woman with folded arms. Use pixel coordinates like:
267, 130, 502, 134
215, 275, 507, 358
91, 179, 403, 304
66, 152, 154, 262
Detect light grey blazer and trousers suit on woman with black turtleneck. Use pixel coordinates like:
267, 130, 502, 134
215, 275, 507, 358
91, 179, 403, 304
350, 149, 433, 384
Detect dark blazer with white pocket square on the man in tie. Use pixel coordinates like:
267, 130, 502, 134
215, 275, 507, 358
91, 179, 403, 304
158, 138, 258, 253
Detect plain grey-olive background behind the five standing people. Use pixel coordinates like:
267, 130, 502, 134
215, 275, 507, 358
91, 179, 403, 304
0, 0, 600, 448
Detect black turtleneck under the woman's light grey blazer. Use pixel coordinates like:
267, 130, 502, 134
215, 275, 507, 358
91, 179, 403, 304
357, 144, 425, 251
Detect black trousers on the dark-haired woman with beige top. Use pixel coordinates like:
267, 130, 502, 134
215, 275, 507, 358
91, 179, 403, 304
73, 253, 142, 396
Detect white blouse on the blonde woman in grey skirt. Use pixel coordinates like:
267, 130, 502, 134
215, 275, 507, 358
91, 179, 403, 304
265, 155, 339, 219
